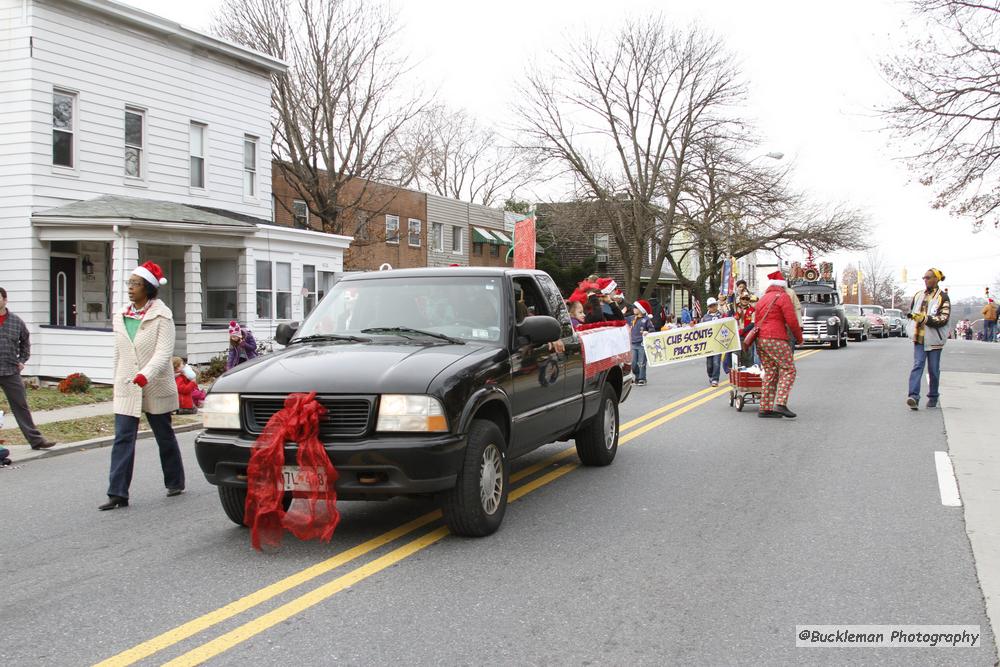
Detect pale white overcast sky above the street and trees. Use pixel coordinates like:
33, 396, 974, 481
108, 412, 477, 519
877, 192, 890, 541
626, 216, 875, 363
128, 0, 1000, 298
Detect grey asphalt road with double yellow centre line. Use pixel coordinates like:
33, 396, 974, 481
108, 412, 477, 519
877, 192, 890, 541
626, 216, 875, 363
0, 339, 996, 665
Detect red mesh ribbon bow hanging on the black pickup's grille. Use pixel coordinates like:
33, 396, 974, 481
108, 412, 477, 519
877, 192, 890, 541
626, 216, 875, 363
243, 391, 340, 549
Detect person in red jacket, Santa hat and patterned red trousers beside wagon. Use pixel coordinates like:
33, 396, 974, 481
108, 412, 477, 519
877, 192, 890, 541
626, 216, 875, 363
757, 271, 802, 419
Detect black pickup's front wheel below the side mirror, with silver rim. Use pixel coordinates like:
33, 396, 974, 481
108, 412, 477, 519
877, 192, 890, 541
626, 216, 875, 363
441, 419, 510, 537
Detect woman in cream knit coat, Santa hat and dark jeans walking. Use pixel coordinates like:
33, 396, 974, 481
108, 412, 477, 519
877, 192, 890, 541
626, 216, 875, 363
98, 262, 184, 510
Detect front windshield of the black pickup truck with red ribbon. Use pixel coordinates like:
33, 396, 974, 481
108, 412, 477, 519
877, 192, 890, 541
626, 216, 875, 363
295, 276, 503, 343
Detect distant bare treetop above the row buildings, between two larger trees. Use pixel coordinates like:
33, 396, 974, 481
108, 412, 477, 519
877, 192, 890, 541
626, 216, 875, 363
399, 105, 538, 206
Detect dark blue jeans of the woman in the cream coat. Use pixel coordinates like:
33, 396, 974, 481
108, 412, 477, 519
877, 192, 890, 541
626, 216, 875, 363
108, 412, 184, 498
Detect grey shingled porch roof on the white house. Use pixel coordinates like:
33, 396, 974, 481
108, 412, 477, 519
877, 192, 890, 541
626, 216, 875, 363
31, 195, 257, 232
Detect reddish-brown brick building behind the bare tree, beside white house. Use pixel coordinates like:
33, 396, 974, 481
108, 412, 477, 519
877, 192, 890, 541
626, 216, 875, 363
271, 164, 431, 271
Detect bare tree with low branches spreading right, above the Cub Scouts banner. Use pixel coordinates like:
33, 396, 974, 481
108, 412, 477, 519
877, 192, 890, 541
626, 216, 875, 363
666, 138, 867, 300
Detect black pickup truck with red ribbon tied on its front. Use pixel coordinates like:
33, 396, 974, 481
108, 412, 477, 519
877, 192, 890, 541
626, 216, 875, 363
195, 267, 633, 536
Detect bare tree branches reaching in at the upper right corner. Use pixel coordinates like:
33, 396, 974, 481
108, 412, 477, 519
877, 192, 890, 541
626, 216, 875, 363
883, 0, 1000, 228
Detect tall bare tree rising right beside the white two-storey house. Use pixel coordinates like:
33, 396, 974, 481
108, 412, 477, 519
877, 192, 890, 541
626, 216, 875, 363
215, 0, 424, 236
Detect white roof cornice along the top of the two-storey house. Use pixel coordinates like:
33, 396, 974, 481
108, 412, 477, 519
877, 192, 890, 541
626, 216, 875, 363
64, 0, 288, 74
